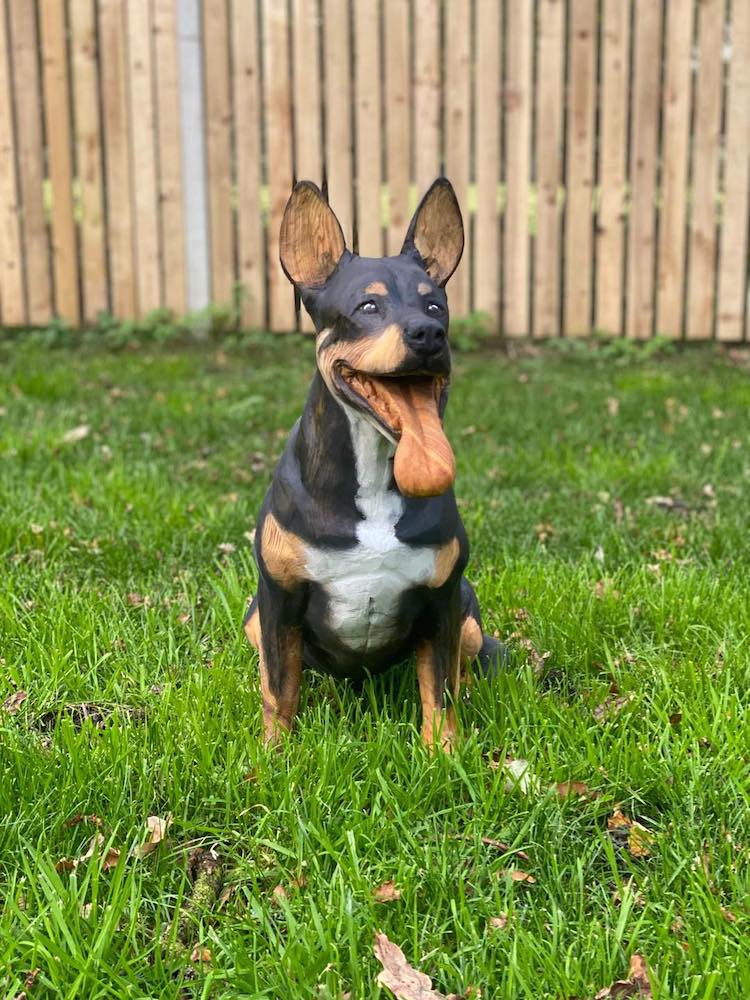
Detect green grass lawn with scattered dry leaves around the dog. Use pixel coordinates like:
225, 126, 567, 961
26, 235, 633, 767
0, 339, 750, 1000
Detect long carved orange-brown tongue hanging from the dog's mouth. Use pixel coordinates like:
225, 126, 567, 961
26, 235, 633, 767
373, 378, 456, 497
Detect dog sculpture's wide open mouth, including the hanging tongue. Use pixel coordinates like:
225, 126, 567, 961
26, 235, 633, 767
335, 364, 456, 497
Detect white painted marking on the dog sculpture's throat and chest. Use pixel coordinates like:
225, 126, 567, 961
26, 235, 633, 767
305, 414, 436, 653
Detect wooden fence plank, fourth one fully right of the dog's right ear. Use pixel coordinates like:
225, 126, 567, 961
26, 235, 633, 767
563, 0, 597, 337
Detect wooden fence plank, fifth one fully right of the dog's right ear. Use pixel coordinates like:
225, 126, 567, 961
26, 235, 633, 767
594, 0, 631, 336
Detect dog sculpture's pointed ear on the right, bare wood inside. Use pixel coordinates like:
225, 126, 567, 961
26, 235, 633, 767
401, 177, 464, 285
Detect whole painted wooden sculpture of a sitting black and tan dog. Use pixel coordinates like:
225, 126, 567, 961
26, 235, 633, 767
245, 179, 506, 747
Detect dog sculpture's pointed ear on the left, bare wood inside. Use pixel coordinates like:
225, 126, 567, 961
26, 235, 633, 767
279, 181, 346, 288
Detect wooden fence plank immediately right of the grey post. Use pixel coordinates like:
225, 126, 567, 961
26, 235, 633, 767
203, 0, 234, 305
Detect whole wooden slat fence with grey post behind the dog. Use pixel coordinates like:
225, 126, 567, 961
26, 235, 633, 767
0, 0, 750, 341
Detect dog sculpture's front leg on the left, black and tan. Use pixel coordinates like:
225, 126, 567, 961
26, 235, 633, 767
251, 577, 304, 744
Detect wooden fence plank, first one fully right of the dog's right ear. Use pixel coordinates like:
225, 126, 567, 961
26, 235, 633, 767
472, 0, 501, 322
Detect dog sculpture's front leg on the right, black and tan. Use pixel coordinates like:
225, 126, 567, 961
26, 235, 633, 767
417, 584, 461, 752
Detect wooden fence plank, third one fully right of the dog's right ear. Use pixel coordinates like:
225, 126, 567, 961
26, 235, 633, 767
534, 0, 564, 337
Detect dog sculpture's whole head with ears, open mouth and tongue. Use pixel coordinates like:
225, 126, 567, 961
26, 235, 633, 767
280, 179, 464, 497
